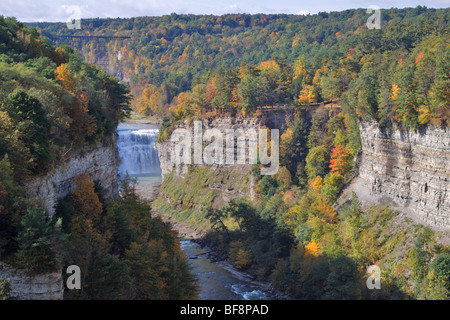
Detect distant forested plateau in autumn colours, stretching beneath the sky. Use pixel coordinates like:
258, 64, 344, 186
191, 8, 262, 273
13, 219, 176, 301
32, 6, 449, 128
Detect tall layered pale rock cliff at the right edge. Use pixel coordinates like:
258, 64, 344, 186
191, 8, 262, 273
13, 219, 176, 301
359, 123, 450, 229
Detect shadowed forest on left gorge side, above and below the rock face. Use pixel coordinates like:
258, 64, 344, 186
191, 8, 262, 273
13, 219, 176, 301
0, 16, 196, 300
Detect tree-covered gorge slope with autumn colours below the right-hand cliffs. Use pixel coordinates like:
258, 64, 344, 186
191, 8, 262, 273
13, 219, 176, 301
154, 107, 450, 300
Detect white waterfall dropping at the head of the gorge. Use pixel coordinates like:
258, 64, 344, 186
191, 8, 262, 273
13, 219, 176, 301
117, 124, 161, 176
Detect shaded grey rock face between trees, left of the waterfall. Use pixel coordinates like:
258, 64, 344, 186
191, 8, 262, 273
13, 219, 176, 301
26, 135, 119, 216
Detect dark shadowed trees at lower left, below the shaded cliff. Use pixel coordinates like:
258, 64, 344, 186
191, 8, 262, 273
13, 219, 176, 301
55, 173, 196, 300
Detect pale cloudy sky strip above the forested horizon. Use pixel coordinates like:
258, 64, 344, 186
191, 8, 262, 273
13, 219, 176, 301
0, 0, 450, 22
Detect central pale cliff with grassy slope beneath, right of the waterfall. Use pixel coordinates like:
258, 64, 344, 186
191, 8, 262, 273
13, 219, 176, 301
156, 117, 261, 225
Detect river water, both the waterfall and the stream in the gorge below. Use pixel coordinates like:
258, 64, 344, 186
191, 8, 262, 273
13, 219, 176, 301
117, 123, 270, 300
